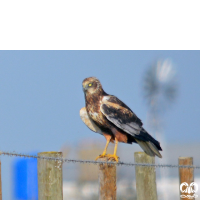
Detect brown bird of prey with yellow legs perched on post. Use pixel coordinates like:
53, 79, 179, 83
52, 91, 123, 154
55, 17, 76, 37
80, 77, 162, 162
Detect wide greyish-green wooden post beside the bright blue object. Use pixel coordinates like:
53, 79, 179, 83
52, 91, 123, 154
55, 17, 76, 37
37, 152, 63, 200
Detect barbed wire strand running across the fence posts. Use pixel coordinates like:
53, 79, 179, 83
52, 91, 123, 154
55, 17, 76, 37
0, 151, 200, 169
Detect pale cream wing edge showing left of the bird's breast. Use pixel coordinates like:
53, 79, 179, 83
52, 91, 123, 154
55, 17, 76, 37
80, 107, 102, 134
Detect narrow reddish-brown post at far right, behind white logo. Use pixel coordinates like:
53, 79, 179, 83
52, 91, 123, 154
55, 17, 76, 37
178, 157, 195, 200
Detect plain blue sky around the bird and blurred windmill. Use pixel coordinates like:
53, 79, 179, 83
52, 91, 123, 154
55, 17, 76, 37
0, 51, 200, 198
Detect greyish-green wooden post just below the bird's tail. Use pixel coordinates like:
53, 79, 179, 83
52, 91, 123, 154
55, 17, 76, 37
134, 152, 157, 200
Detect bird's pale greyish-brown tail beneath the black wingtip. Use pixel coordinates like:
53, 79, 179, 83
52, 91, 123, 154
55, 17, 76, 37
135, 139, 162, 158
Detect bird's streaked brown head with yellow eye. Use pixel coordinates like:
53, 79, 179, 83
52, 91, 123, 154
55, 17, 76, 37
82, 77, 103, 95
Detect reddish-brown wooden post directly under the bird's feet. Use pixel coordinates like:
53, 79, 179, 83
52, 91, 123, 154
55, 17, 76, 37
99, 158, 117, 200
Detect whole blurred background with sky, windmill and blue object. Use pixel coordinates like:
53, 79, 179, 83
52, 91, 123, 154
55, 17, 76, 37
0, 51, 200, 200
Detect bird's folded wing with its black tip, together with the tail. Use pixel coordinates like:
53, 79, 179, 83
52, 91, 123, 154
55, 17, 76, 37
100, 96, 162, 158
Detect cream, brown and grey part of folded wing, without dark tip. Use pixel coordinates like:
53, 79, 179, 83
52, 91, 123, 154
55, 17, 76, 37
100, 95, 142, 136
